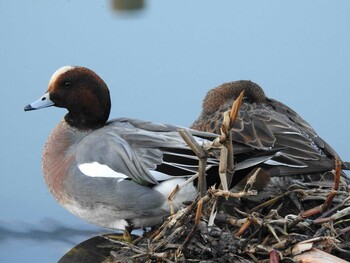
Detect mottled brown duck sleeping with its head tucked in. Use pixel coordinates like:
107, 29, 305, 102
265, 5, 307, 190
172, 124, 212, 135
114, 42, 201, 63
190, 80, 349, 193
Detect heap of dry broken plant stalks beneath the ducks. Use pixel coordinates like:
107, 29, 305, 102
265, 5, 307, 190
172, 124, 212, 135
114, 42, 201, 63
105, 172, 350, 262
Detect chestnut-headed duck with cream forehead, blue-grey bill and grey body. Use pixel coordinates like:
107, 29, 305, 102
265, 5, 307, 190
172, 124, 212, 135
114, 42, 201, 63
24, 66, 218, 231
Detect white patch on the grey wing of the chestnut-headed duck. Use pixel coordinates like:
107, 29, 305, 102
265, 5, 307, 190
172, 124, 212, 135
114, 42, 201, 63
78, 162, 128, 182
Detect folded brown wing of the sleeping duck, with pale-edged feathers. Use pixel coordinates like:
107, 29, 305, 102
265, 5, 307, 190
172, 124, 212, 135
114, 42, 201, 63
228, 100, 344, 175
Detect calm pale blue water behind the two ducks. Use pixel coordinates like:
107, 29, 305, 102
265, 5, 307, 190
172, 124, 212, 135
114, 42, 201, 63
0, 0, 350, 262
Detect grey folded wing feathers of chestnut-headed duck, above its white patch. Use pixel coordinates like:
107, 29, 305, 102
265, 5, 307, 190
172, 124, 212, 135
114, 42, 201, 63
76, 118, 217, 184
